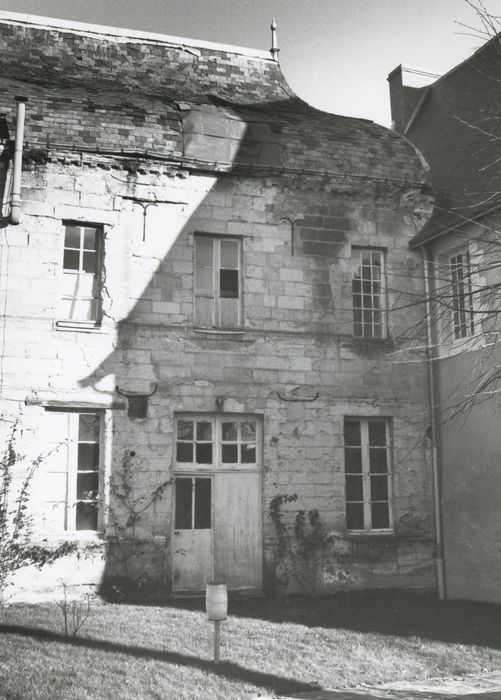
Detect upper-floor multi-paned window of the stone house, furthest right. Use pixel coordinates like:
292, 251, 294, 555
352, 248, 386, 338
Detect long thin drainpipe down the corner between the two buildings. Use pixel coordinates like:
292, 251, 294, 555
421, 248, 446, 600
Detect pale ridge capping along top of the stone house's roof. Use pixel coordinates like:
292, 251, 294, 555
0, 10, 278, 64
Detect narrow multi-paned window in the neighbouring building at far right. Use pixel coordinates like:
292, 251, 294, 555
450, 249, 475, 340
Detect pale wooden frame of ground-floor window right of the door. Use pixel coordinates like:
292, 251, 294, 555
343, 416, 393, 533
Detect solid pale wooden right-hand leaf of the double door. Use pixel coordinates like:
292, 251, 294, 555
214, 473, 262, 589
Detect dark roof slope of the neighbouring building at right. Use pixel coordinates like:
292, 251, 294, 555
406, 35, 501, 247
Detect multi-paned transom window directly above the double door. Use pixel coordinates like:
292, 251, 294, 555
176, 415, 258, 468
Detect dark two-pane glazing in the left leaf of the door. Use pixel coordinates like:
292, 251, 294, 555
174, 476, 212, 530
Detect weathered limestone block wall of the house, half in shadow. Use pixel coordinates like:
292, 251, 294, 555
0, 154, 434, 592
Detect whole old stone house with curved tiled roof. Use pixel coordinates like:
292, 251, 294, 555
0, 12, 435, 597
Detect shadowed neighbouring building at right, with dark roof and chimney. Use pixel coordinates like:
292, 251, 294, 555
389, 36, 501, 603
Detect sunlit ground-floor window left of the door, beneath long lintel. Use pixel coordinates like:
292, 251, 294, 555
35, 409, 103, 532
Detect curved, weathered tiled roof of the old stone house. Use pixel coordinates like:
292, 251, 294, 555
0, 13, 422, 182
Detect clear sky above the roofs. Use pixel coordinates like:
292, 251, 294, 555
0, 0, 501, 126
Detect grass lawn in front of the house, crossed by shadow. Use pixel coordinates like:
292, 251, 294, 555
0, 591, 501, 700
